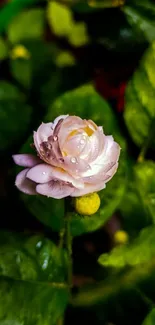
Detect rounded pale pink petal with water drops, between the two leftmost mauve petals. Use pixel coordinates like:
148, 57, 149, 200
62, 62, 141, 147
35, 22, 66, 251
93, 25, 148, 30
27, 164, 52, 184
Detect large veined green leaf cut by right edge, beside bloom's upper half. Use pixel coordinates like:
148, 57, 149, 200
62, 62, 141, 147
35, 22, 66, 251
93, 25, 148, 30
124, 43, 155, 146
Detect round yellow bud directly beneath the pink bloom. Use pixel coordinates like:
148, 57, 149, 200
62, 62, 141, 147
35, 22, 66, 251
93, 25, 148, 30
74, 193, 100, 215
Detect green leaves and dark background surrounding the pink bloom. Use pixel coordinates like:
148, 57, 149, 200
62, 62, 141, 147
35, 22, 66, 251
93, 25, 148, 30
0, 0, 155, 325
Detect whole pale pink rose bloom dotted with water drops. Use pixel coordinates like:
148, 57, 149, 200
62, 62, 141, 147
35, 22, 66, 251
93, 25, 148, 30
13, 115, 120, 199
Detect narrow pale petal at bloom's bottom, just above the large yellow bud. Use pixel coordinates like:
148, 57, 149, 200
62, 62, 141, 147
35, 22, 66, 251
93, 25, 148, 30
70, 182, 106, 197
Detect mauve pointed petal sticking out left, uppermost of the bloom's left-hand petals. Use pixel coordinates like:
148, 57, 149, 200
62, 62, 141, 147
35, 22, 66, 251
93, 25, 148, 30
12, 154, 41, 167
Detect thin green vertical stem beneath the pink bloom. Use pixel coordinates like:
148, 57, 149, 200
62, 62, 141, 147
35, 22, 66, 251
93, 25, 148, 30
66, 217, 73, 288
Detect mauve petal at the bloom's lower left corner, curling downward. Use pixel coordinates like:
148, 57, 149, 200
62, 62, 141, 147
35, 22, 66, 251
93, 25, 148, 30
15, 168, 37, 195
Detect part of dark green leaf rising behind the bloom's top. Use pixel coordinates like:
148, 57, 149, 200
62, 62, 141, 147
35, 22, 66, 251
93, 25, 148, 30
46, 84, 126, 150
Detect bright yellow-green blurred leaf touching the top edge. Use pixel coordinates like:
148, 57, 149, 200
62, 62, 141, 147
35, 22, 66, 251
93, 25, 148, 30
47, 1, 74, 37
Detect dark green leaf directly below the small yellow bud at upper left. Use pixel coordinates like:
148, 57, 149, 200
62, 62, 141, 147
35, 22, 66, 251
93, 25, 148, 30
10, 59, 32, 88
